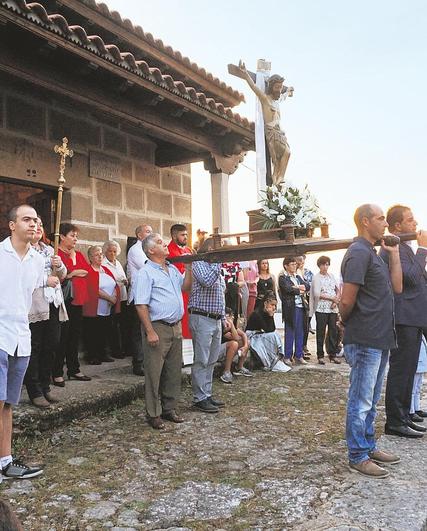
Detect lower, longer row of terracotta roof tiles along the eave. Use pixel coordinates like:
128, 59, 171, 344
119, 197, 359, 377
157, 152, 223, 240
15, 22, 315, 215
0, 0, 254, 130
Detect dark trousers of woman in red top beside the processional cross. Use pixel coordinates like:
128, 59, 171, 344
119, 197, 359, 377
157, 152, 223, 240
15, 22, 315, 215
52, 302, 82, 378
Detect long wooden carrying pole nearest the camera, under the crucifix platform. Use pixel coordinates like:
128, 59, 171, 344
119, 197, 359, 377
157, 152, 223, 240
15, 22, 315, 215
169, 232, 417, 263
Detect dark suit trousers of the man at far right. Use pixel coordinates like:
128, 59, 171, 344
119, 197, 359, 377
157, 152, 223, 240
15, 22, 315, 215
385, 325, 423, 427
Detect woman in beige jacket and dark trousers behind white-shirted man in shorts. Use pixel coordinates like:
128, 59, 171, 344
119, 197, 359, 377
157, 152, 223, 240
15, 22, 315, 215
24, 218, 68, 408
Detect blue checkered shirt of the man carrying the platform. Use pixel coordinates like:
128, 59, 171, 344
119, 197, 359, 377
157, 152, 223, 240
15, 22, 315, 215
188, 262, 225, 317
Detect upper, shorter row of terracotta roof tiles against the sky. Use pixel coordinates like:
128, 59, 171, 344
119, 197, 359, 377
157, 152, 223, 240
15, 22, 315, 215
71, 0, 245, 105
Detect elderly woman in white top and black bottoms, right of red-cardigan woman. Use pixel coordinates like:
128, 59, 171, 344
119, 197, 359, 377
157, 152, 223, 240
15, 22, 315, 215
102, 240, 130, 359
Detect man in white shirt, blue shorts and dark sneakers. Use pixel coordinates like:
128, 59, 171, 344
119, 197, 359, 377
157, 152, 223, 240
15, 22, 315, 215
0, 205, 45, 479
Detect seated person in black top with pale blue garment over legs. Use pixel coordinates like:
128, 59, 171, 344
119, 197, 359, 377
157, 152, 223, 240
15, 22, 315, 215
246, 291, 290, 372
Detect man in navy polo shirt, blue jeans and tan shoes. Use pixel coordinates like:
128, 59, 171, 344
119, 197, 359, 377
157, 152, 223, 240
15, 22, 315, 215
339, 204, 402, 478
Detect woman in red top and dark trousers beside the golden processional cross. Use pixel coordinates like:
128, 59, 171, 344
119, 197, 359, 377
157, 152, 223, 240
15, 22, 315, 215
52, 223, 91, 387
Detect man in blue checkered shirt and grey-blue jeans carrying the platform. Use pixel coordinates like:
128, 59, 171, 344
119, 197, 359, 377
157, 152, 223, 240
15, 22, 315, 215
188, 238, 229, 413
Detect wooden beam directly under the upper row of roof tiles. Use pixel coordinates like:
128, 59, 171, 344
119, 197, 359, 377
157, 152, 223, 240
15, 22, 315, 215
57, 0, 244, 107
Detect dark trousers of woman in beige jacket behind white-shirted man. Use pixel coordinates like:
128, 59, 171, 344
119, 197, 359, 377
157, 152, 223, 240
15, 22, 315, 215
24, 304, 60, 399
